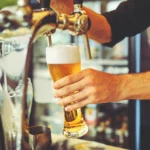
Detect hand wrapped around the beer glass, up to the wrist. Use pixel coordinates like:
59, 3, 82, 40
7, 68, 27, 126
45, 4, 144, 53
54, 69, 122, 111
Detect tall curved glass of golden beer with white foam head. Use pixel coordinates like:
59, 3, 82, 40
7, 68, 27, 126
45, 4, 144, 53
46, 44, 88, 138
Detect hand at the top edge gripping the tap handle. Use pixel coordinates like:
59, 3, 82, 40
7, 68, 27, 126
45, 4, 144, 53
37, 0, 73, 14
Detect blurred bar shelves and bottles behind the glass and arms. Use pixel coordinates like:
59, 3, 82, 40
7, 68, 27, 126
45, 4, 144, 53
0, 0, 150, 148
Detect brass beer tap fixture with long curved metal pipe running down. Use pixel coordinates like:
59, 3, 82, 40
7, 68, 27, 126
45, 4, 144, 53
0, 0, 91, 149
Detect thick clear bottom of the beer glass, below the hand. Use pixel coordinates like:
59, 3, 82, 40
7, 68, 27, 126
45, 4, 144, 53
63, 125, 88, 138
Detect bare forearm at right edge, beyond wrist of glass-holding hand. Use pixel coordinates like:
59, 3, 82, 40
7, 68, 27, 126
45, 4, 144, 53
118, 72, 150, 100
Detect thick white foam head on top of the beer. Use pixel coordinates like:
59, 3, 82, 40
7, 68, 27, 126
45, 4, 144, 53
46, 44, 80, 64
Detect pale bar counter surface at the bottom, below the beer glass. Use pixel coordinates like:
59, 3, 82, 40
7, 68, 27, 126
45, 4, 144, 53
52, 134, 127, 150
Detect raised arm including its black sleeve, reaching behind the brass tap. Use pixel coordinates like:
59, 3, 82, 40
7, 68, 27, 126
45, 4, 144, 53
84, 0, 150, 47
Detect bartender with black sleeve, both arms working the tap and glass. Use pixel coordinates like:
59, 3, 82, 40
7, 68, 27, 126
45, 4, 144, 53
47, 0, 150, 150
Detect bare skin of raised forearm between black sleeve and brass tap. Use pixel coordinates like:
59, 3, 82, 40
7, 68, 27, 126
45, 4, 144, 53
83, 6, 111, 44
